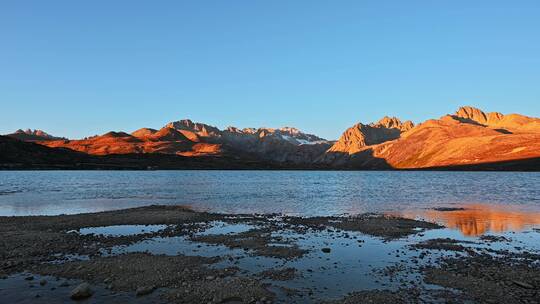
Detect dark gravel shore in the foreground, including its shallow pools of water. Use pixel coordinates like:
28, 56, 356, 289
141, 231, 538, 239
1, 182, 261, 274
0, 206, 540, 303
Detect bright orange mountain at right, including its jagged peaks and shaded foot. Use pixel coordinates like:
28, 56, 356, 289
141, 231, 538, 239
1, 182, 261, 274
323, 107, 540, 169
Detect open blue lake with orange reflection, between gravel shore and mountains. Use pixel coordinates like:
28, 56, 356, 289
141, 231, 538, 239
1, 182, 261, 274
0, 171, 540, 233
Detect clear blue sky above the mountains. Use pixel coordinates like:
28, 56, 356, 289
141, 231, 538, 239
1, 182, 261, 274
0, 0, 540, 139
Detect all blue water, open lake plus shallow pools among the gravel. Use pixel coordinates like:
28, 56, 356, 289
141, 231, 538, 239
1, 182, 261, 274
0, 171, 540, 303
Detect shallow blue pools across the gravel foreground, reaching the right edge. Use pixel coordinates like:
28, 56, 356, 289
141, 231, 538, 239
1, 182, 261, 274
102, 218, 540, 302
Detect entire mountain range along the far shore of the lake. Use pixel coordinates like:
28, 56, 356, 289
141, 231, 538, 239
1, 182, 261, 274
0, 106, 540, 170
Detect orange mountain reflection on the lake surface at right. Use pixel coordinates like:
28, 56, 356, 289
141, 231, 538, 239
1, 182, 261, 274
402, 204, 540, 236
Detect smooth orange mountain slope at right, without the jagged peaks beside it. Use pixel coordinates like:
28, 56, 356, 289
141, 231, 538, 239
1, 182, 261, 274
372, 116, 540, 168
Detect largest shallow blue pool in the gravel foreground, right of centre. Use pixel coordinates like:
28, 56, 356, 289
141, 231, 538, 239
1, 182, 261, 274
105, 223, 428, 298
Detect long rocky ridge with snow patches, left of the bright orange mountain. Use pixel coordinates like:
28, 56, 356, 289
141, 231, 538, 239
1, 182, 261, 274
8, 119, 330, 163
